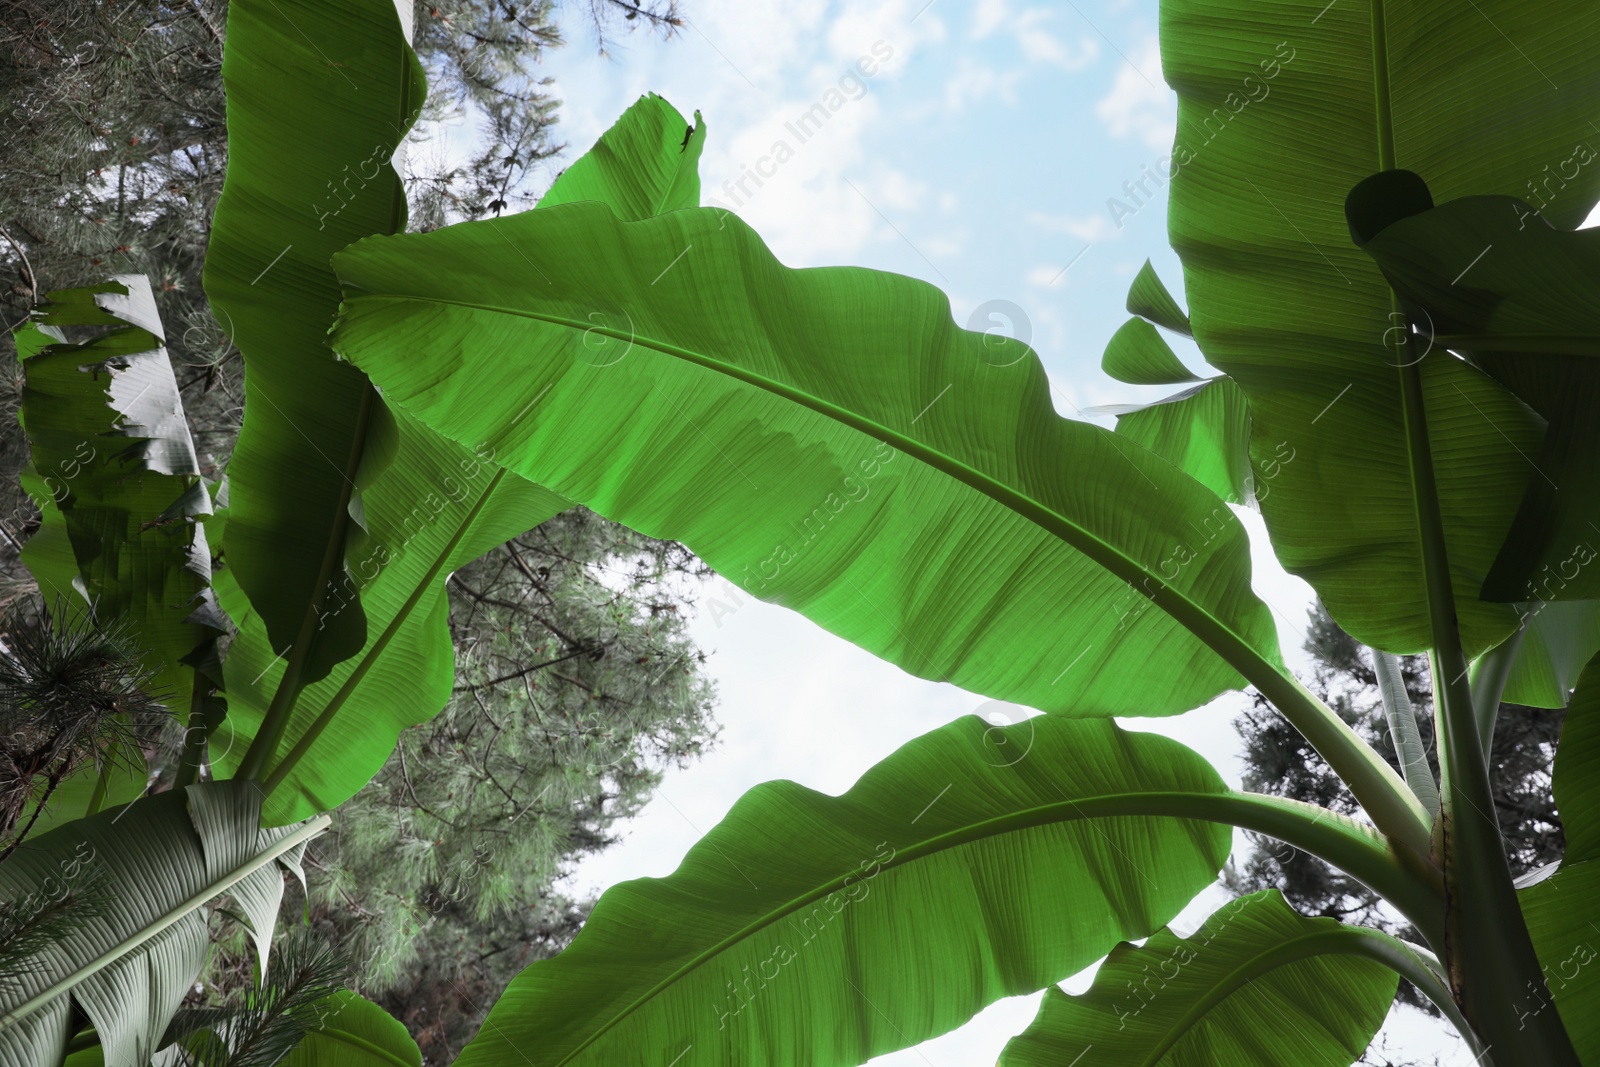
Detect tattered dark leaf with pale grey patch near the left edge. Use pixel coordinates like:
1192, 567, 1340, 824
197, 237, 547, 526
18, 275, 224, 832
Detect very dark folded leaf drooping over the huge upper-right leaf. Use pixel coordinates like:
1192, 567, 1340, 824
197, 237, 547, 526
1350, 177, 1600, 601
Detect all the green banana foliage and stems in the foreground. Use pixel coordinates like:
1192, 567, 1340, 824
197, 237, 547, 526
0, 0, 1600, 1067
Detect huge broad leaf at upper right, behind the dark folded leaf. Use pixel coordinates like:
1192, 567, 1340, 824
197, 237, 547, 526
1162, 0, 1600, 656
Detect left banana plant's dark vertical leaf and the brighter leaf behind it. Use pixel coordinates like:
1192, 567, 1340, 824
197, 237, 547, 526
196, 0, 706, 822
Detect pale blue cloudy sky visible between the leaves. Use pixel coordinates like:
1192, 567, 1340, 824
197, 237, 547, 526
441, 0, 1472, 1067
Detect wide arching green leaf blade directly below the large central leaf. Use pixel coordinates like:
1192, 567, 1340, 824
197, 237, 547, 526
458, 717, 1230, 1067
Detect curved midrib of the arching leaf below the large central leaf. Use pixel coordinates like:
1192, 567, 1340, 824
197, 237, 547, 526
540, 790, 1387, 1067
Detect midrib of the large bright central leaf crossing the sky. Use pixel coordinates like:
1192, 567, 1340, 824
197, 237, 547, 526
350, 286, 1283, 685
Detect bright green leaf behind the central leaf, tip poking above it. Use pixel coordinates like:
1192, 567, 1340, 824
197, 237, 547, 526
216, 94, 706, 824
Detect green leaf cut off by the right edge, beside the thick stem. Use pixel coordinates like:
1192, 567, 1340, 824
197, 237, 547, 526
1517, 657, 1600, 1064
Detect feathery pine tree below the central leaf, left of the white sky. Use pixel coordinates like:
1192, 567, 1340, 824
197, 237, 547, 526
296, 510, 714, 1062
